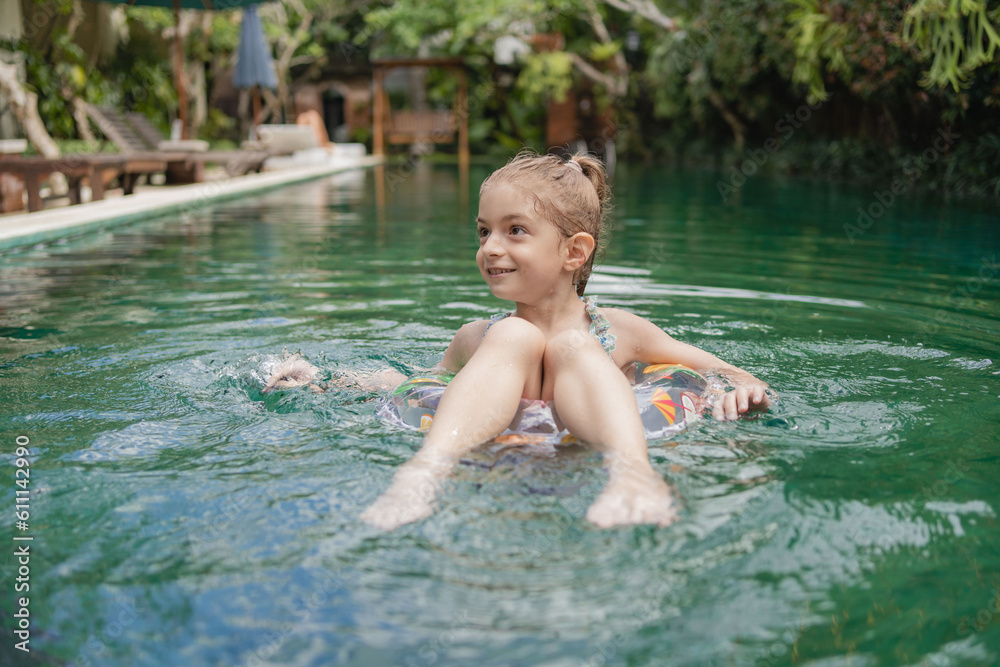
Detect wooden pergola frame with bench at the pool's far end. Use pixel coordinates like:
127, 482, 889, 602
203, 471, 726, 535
372, 58, 469, 169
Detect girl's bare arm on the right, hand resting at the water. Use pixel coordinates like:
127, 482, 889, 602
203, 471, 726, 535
608, 309, 771, 420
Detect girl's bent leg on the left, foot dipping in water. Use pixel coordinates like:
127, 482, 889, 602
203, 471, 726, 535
361, 317, 545, 530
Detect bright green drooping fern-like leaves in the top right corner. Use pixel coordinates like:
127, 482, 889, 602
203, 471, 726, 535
903, 0, 1000, 91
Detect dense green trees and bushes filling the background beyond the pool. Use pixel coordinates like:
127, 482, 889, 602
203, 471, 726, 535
9, 0, 1000, 196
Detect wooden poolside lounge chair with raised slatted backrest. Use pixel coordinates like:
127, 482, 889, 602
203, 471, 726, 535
87, 104, 271, 183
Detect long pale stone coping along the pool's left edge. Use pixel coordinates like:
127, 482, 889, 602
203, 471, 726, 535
0, 156, 383, 250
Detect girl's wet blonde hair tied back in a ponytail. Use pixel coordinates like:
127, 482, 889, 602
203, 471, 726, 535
479, 150, 611, 296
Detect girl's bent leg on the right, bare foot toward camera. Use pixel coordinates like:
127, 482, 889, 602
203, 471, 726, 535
543, 331, 677, 527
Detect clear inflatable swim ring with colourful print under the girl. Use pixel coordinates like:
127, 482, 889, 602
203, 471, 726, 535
378, 363, 707, 444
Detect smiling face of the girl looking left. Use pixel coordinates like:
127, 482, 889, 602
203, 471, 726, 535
476, 183, 573, 302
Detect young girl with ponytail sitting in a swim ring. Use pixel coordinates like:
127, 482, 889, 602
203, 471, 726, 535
361, 153, 770, 530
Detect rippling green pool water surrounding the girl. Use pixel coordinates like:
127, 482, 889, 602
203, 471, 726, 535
0, 165, 1000, 667
